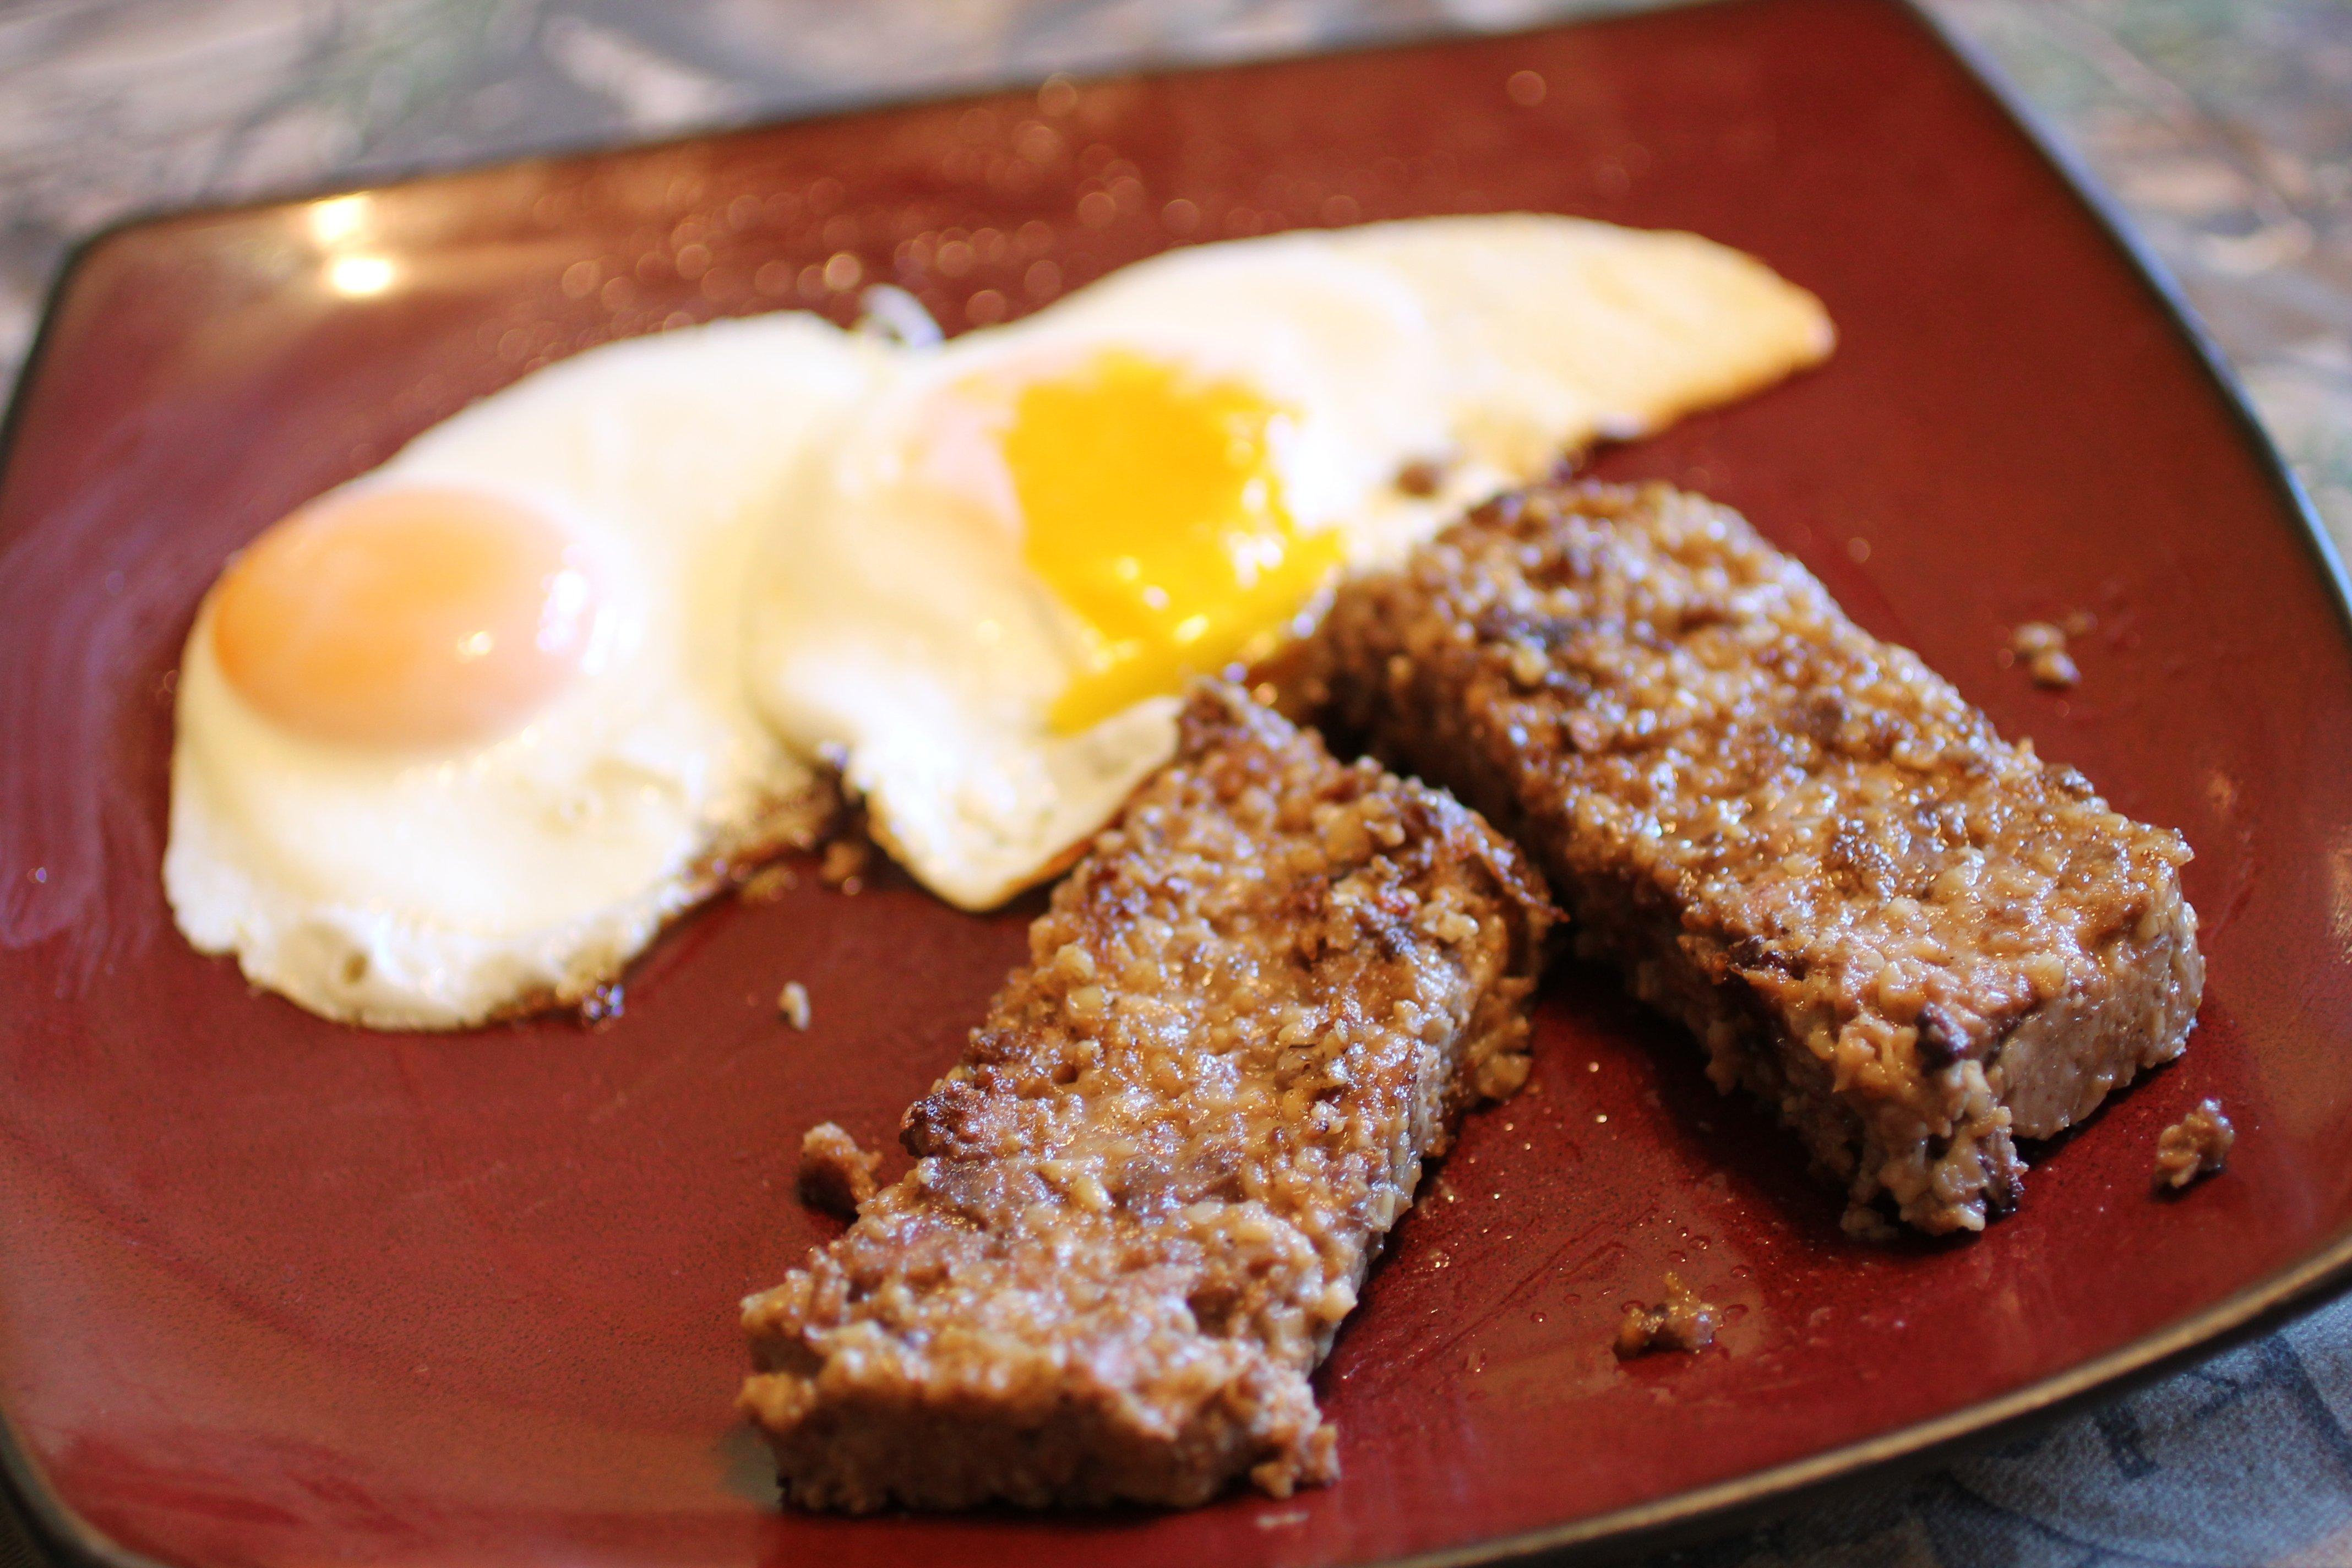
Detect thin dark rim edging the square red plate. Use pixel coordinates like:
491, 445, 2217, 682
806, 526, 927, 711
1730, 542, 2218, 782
0, 0, 2352, 1568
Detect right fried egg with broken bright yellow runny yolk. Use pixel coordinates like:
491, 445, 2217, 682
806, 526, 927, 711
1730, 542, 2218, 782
745, 214, 1832, 910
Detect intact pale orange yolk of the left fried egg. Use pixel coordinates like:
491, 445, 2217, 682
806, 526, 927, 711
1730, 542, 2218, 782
211, 487, 595, 748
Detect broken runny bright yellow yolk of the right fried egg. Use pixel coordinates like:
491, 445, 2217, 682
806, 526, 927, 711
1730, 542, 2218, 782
1002, 350, 1338, 733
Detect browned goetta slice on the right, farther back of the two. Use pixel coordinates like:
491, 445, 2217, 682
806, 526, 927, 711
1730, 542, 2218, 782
1303, 482, 2204, 1232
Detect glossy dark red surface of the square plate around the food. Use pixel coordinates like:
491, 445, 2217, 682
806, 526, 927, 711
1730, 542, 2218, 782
0, 0, 2352, 1568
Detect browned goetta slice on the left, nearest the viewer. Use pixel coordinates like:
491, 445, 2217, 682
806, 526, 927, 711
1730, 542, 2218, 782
741, 687, 1550, 1512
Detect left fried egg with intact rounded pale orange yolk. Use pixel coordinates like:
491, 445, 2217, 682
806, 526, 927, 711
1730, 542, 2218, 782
165, 315, 887, 1030
